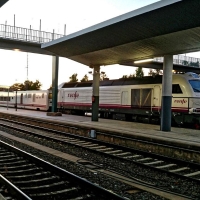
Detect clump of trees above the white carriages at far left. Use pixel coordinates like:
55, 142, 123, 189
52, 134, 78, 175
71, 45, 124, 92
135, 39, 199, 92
10, 80, 42, 90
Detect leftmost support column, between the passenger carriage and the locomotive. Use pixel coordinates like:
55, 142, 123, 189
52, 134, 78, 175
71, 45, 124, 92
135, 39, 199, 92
51, 56, 59, 112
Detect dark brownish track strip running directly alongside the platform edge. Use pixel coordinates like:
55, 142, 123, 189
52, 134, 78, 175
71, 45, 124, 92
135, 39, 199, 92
1, 113, 200, 163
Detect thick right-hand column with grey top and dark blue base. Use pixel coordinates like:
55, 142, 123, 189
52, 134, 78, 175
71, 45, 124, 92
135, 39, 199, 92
160, 55, 173, 131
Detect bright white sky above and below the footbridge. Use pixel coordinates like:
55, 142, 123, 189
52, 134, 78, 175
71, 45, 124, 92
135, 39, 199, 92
0, 0, 200, 89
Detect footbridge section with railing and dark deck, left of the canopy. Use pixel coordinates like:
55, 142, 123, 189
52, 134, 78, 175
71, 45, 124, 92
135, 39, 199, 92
0, 24, 63, 55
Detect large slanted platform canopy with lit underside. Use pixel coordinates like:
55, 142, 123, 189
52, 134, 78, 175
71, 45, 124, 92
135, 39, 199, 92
42, 0, 200, 66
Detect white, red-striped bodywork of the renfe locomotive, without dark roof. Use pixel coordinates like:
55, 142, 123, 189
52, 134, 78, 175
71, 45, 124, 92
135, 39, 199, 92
58, 74, 200, 113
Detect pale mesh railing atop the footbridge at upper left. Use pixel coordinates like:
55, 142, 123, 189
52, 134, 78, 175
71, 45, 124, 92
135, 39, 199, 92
0, 24, 64, 44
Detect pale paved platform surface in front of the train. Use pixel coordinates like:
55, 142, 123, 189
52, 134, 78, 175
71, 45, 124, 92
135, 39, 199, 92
0, 107, 200, 149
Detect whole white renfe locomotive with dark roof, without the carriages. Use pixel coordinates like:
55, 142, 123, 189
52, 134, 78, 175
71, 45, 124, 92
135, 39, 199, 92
58, 73, 200, 124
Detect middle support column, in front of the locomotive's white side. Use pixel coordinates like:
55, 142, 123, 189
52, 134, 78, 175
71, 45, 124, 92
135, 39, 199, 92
92, 66, 100, 121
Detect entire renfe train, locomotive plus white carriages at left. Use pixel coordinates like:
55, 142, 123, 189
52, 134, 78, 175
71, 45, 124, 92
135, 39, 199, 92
0, 72, 200, 128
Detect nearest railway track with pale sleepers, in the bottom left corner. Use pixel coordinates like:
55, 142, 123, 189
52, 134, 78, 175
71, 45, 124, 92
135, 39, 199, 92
0, 141, 124, 200
